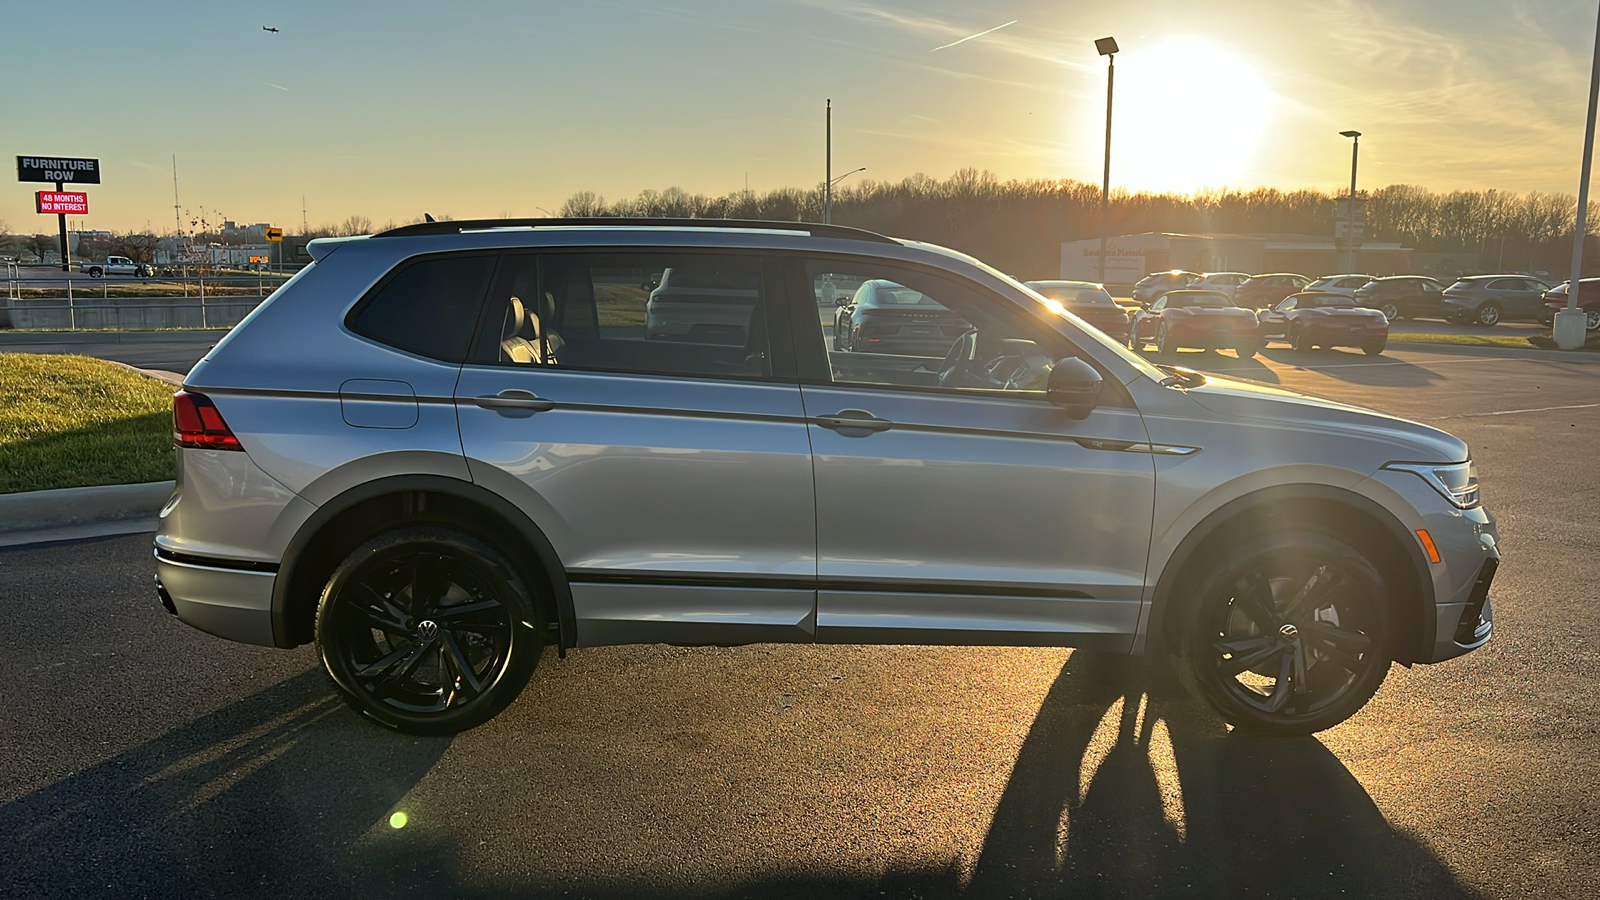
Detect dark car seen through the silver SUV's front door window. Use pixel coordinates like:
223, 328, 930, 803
834, 279, 971, 357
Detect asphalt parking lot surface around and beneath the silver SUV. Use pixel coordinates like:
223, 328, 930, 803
0, 344, 1600, 898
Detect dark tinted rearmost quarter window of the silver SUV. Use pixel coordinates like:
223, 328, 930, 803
346, 255, 494, 362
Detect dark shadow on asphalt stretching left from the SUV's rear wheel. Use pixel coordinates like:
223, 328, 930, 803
0, 669, 451, 897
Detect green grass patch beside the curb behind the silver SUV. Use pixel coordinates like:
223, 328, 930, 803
0, 352, 174, 493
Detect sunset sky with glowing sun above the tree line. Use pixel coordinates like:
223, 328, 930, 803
0, 0, 1595, 231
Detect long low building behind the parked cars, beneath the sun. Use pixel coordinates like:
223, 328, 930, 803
1061, 232, 1414, 285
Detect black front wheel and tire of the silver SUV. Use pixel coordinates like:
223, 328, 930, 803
1174, 527, 1395, 737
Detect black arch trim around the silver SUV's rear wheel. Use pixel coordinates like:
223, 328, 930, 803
272, 476, 578, 653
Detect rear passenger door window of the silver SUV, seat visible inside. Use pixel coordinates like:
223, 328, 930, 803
474, 251, 771, 378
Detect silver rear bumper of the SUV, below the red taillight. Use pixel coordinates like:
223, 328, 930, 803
155, 549, 277, 647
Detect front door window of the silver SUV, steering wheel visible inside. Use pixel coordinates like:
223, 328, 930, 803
806, 261, 1075, 396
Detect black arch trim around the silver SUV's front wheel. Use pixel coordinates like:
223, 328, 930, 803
1146, 484, 1437, 663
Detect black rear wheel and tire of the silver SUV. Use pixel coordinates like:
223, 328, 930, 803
317, 525, 544, 735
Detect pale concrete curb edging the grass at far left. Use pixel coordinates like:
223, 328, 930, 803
0, 482, 173, 546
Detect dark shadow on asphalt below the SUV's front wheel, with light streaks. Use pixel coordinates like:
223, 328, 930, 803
965, 652, 1474, 897
